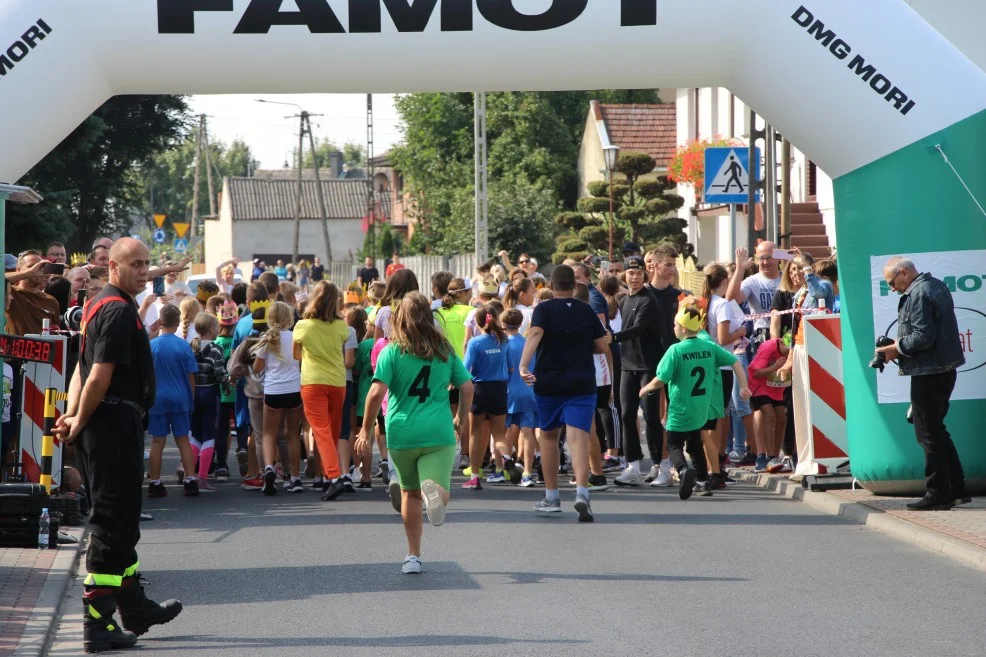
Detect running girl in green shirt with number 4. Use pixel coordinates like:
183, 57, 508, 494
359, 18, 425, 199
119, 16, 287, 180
355, 292, 472, 574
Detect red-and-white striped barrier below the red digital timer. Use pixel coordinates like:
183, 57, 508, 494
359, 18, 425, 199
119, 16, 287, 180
20, 335, 68, 487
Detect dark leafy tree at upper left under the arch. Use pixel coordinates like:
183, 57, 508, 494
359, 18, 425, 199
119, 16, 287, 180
7, 96, 189, 252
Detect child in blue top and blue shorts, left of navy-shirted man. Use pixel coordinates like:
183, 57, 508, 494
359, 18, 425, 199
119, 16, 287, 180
500, 308, 538, 488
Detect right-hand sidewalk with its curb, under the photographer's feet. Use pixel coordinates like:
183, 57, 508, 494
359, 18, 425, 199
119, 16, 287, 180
730, 468, 986, 571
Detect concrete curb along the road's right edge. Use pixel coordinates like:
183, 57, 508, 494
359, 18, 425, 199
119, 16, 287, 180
729, 470, 986, 571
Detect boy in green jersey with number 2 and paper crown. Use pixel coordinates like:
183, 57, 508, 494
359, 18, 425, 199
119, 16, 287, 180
640, 306, 750, 500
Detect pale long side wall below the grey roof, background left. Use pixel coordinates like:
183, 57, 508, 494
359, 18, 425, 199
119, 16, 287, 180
229, 219, 363, 267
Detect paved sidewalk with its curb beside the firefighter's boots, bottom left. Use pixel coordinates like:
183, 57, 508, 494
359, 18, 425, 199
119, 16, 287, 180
0, 527, 85, 657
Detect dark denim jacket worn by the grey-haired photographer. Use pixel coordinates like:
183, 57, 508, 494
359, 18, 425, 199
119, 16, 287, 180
897, 272, 965, 376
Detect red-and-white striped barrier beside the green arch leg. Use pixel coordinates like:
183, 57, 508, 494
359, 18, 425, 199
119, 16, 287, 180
795, 315, 849, 474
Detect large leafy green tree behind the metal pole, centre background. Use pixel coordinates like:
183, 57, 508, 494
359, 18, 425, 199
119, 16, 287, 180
392, 90, 658, 256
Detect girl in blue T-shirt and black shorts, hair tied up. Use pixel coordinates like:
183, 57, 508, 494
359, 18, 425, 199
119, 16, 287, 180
462, 304, 508, 490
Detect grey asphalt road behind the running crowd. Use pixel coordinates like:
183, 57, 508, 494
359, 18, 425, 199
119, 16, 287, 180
49, 450, 986, 657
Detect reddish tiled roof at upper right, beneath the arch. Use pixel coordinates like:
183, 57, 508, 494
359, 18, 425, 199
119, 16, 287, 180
598, 103, 678, 169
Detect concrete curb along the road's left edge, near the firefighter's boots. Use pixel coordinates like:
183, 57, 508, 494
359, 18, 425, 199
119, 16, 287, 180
12, 525, 89, 657
